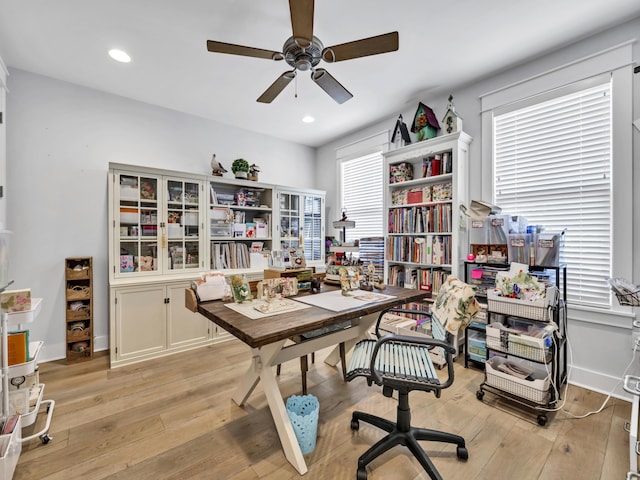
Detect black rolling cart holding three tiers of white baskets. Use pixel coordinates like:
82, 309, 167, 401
476, 265, 567, 426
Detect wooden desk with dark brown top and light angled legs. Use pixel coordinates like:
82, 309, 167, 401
198, 287, 426, 475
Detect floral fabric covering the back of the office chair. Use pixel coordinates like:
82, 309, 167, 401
432, 275, 480, 340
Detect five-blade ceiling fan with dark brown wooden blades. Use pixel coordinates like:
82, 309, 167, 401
207, 0, 398, 103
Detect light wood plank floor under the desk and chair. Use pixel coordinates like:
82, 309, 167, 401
14, 340, 631, 480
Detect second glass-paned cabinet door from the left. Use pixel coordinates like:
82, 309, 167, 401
166, 179, 202, 271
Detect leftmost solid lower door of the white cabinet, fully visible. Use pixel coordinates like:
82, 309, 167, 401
111, 285, 167, 364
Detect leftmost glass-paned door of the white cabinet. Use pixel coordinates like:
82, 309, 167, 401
114, 174, 161, 275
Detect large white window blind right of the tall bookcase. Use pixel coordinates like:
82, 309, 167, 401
493, 82, 612, 307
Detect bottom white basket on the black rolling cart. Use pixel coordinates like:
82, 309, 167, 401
485, 357, 549, 404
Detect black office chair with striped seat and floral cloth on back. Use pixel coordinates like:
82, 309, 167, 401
347, 276, 480, 480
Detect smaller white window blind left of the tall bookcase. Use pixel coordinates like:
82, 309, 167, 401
335, 151, 384, 242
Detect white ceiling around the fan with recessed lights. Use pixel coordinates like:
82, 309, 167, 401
0, 0, 640, 146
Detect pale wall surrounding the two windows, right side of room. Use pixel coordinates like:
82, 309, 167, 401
315, 18, 640, 396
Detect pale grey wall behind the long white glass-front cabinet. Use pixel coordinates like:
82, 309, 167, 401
5, 69, 315, 360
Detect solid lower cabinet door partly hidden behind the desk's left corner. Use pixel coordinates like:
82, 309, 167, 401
167, 282, 214, 348
